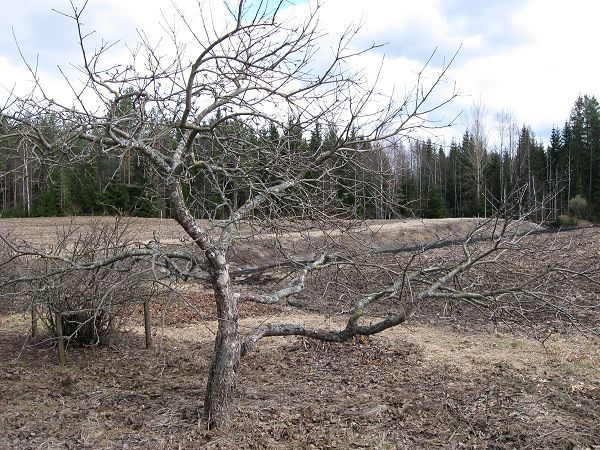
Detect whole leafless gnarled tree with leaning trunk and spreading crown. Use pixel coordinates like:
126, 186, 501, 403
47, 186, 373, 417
2, 1, 596, 426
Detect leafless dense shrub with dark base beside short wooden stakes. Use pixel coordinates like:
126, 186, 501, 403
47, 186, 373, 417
28, 219, 154, 345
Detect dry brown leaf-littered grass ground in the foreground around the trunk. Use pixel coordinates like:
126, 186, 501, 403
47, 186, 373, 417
0, 219, 600, 449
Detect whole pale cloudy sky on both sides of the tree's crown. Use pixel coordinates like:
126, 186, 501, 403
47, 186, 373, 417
0, 0, 600, 146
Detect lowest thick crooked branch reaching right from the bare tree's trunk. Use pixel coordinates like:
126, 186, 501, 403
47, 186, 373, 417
242, 217, 600, 355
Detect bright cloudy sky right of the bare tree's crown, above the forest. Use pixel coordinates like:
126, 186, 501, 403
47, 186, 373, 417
304, 0, 600, 144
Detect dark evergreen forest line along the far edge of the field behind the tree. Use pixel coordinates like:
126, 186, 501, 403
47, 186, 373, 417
0, 95, 600, 220
